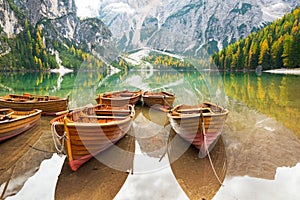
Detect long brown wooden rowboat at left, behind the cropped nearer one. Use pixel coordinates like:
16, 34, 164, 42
0, 93, 69, 115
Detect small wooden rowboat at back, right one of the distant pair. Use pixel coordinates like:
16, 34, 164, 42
142, 91, 175, 110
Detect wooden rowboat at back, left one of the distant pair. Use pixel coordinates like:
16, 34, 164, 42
96, 90, 142, 106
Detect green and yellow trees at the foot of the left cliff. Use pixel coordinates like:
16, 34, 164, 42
0, 20, 103, 71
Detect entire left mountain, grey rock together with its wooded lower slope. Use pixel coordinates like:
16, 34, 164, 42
0, 0, 112, 71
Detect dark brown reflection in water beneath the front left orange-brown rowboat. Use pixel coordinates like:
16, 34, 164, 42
55, 135, 135, 200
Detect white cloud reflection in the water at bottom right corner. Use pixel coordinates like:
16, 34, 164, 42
213, 163, 300, 200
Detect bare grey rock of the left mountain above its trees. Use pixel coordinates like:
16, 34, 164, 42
0, 0, 113, 61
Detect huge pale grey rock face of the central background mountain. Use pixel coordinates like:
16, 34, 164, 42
99, 0, 299, 55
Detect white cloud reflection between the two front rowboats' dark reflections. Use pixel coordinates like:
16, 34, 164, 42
114, 143, 188, 200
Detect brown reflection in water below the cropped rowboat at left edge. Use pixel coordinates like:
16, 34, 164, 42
0, 117, 53, 199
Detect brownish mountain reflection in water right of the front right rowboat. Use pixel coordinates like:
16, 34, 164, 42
223, 100, 300, 179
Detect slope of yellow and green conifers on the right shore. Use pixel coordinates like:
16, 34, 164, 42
212, 7, 300, 70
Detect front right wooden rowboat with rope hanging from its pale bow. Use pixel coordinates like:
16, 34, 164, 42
168, 102, 229, 157
